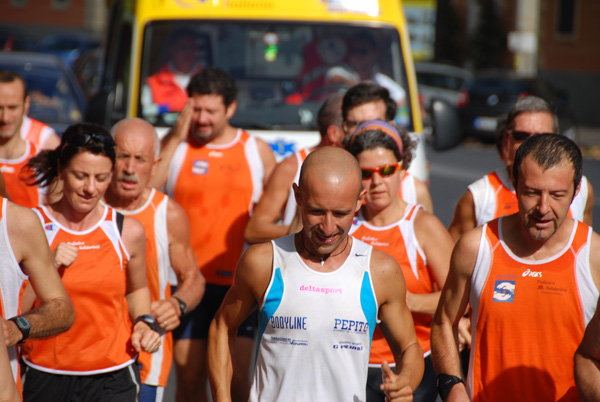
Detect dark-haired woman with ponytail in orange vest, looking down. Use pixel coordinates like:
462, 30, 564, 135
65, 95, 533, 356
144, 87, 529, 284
22, 123, 160, 402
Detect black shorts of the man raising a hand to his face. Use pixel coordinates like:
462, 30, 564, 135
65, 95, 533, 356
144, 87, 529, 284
171, 283, 258, 340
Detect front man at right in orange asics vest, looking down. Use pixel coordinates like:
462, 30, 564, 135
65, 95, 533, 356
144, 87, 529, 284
431, 134, 600, 401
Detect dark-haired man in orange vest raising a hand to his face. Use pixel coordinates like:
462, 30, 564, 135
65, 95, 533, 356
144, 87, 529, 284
148, 68, 275, 402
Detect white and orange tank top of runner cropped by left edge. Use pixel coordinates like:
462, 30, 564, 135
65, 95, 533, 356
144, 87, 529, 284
0, 197, 27, 381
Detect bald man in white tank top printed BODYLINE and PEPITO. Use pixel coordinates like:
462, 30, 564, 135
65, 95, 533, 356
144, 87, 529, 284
208, 147, 423, 401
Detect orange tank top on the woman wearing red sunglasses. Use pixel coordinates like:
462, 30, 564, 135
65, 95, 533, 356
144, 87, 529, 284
351, 205, 434, 367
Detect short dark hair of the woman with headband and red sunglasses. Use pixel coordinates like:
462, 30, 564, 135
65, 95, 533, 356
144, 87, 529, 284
342, 122, 417, 170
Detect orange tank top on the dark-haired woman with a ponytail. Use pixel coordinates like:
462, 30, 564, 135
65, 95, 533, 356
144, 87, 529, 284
22, 206, 136, 375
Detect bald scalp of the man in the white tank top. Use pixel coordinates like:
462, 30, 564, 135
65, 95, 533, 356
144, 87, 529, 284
298, 147, 362, 198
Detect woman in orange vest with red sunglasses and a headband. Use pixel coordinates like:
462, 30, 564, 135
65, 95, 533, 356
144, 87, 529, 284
345, 120, 454, 402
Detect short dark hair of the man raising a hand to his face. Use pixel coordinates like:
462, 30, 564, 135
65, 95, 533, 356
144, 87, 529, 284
187, 67, 237, 107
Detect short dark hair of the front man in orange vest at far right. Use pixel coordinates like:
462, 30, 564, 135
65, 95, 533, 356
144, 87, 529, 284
513, 134, 583, 196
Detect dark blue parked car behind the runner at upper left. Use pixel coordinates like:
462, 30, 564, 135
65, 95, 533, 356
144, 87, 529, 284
0, 52, 86, 134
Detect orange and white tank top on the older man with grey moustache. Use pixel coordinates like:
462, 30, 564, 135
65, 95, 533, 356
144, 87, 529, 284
119, 189, 173, 387
